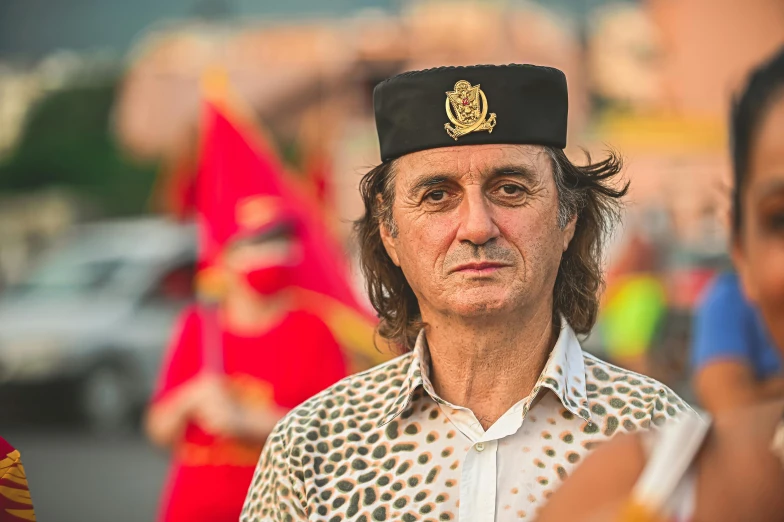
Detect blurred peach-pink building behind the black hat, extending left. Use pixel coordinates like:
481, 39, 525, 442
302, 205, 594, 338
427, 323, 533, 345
110, 2, 589, 240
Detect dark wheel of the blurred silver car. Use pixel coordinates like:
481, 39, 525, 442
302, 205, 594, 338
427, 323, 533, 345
80, 365, 134, 433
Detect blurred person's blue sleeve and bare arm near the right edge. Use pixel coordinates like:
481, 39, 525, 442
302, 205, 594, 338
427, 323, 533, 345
691, 273, 784, 413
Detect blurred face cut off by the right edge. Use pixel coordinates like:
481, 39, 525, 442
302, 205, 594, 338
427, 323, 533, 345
733, 93, 784, 353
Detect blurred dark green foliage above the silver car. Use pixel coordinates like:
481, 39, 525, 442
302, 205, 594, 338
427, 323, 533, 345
0, 78, 156, 216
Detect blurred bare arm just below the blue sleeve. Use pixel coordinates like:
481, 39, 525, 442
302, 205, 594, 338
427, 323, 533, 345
694, 360, 784, 413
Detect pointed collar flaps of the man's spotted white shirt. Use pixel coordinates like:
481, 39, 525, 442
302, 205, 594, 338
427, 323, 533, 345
378, 317, 591, 426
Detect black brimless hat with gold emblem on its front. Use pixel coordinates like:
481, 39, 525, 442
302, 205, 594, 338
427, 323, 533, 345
373, 64, 568, 161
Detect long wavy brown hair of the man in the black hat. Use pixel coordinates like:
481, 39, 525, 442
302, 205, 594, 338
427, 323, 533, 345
354, 147, 629, 350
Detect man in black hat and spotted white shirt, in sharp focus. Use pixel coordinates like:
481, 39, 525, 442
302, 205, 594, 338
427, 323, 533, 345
241, 65, 688, 522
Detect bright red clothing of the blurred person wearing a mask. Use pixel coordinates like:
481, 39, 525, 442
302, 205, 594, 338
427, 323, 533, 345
154, 309, 346, 522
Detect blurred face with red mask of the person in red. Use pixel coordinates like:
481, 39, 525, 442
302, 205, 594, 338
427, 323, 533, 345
223, 228, 301, 296
